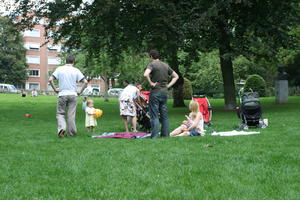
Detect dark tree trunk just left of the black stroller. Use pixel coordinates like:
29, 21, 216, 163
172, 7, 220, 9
219, 23, 236, 110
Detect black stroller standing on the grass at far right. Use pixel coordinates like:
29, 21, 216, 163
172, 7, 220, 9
237, 90, 266, 130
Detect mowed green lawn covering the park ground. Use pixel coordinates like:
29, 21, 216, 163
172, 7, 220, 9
0, 94, 300, 200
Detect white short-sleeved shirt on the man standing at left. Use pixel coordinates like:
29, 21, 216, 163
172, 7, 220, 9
52, 64, 84, 96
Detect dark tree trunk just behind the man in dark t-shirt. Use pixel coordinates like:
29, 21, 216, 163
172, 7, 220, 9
169, 48, 185, 108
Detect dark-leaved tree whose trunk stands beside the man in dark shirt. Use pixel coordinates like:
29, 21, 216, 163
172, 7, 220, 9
11, 0, 191, 106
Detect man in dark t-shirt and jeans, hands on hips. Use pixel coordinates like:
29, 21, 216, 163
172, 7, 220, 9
144, 50, 178, 138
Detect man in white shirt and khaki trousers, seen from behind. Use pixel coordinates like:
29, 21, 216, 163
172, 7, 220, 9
49, 56, 88, 137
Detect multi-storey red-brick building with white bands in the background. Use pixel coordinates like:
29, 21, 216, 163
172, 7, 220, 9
23, 23, 105, 92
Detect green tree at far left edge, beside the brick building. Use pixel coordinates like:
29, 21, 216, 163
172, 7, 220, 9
0, 16, 27, 85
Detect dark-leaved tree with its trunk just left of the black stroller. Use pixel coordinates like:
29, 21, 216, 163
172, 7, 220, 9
182, 0, 299, 109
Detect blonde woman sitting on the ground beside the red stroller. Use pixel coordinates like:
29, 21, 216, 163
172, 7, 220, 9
170, 100, 204, 136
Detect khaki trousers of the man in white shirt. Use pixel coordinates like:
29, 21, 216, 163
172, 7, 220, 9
56, 95, 77, 136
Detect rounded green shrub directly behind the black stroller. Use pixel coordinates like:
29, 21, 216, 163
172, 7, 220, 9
244, 74, 266, 97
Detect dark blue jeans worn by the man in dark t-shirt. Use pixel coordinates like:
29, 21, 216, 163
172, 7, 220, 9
149, 92, 170, 138
